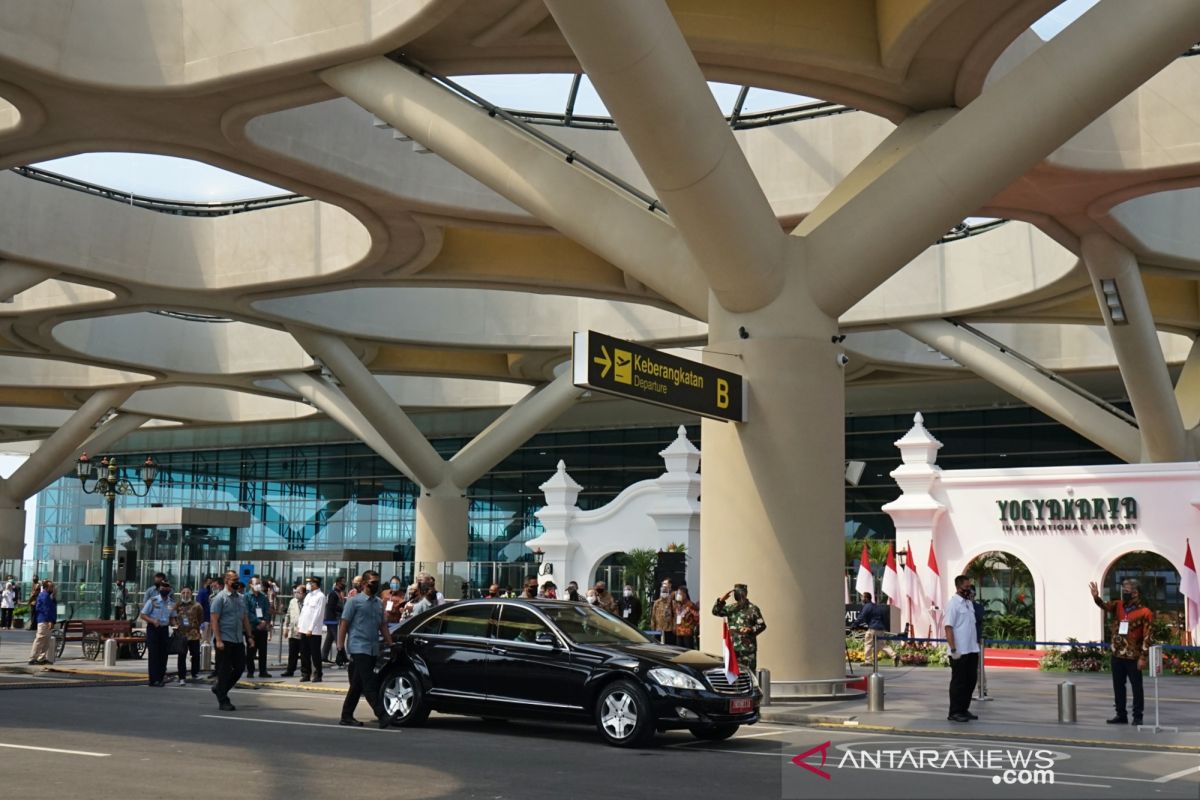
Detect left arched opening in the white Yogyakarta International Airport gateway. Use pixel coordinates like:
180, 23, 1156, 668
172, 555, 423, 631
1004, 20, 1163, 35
952, 551, 1037, 649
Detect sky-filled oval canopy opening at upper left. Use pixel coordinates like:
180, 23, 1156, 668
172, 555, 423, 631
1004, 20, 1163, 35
31, 152, 289, 203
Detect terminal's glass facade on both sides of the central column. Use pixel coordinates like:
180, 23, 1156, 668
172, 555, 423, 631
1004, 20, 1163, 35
35, 408, 1132, 561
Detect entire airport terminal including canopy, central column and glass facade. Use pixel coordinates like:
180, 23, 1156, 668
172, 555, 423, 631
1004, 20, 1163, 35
0, 0, 1200, 681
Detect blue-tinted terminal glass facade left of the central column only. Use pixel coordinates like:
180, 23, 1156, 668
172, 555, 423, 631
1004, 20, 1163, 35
34, 426, 700, 561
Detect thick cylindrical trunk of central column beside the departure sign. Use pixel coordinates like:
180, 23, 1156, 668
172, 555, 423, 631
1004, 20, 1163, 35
694, 337, 845, 681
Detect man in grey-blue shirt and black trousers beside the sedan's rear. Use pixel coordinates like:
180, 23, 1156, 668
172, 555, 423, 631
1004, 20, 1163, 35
337, 570, 391, 728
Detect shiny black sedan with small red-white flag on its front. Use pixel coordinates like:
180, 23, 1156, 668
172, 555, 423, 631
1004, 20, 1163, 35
380, 600, 762, 747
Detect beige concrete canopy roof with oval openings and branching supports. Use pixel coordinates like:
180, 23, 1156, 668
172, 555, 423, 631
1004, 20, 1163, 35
0, 0, 1200, 690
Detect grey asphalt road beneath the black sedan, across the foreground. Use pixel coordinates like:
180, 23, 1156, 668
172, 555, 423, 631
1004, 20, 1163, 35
0, 679, 1200, 800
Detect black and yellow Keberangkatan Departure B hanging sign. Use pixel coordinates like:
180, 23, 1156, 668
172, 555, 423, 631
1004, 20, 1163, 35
571, 331, 745, 422
